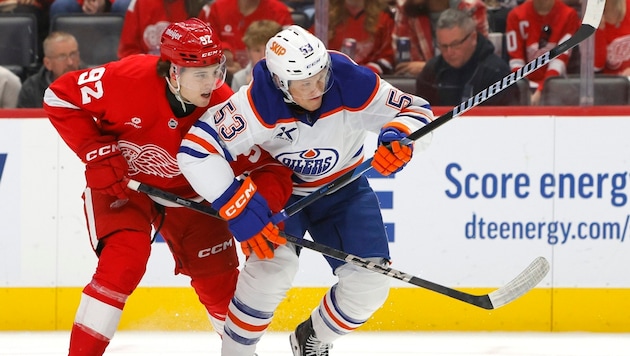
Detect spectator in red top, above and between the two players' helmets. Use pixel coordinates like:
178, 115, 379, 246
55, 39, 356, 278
199, 0, 293, 75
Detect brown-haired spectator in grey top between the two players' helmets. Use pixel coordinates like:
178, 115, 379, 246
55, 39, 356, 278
231, 20, 282, 91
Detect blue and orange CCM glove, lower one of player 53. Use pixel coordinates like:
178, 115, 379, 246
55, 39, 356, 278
212, 177, 287, 259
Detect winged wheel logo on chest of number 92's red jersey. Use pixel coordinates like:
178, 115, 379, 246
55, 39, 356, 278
118, 141, 181, 178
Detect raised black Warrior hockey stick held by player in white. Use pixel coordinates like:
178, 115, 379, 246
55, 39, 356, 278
272, 0, 606, 222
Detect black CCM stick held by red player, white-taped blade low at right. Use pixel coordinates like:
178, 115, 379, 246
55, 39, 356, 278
128, 180, 549, 309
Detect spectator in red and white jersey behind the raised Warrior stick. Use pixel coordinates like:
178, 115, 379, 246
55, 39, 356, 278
505, 0, 580, 105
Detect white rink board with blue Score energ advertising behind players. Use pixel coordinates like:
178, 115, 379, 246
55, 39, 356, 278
0, 116, 630, 288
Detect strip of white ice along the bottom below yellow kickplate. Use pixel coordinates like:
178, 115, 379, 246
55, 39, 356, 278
0, 331, 630, 356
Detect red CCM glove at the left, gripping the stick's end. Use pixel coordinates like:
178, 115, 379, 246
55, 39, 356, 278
79, 136, 129, 206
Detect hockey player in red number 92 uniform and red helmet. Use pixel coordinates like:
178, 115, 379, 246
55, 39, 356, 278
44, 18, 291, 356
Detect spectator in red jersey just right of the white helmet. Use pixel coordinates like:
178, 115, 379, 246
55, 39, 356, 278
311, 0, 394, 75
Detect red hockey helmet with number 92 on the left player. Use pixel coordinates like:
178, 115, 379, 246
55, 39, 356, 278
160, 17, 223, 67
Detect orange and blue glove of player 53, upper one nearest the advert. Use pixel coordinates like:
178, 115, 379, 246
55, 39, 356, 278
372, 127, 413, 176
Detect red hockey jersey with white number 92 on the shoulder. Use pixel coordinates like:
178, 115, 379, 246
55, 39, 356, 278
44, 55, 232, 197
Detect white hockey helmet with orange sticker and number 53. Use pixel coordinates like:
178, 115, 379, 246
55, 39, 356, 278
265, 25, 330, 101
